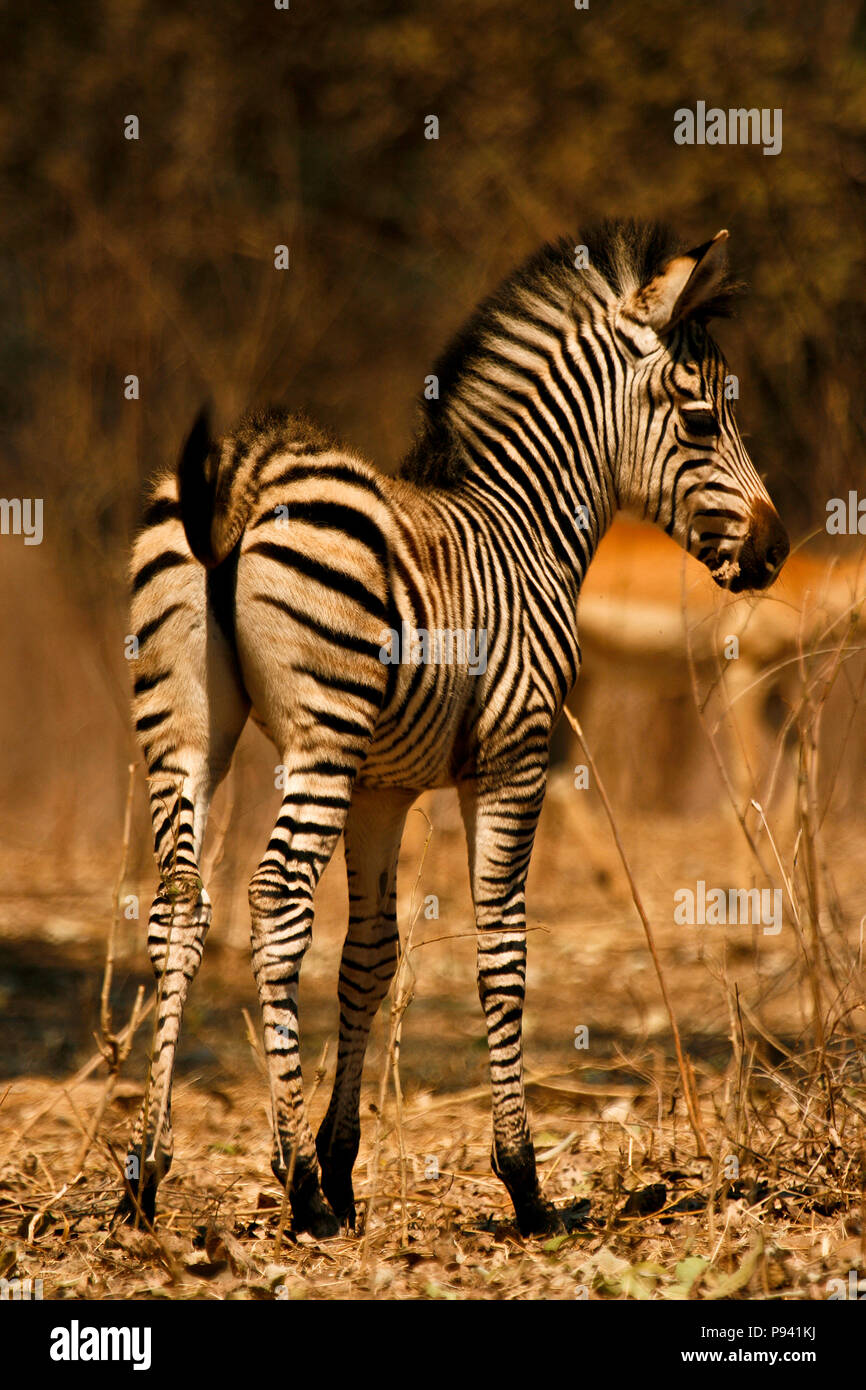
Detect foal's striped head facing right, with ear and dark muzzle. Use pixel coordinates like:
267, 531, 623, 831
614, 231, 788, 592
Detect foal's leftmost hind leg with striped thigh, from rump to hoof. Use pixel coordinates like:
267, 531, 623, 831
121, 475, 250, 1220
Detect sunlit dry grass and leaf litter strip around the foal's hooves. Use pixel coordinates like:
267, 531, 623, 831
0, 1041, 865, 1300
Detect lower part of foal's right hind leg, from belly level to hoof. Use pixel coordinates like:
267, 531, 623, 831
250, 759, 352, 1238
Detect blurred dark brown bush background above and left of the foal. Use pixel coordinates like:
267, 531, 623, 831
0, 0, 866, 877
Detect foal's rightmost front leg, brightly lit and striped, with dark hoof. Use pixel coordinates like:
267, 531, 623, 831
459, 767, 564, 1236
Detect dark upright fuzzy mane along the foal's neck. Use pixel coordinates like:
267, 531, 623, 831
400, 218, 741, 488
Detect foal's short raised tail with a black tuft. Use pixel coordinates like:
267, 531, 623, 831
178, 406, 259, 570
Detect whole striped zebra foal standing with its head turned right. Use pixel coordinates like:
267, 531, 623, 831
125, 222, 788, 1236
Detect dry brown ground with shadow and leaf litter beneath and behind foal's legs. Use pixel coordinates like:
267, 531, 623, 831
0, 773, 866, 1300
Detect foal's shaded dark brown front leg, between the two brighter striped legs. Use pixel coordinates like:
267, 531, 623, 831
316, 787, 416, 1227
